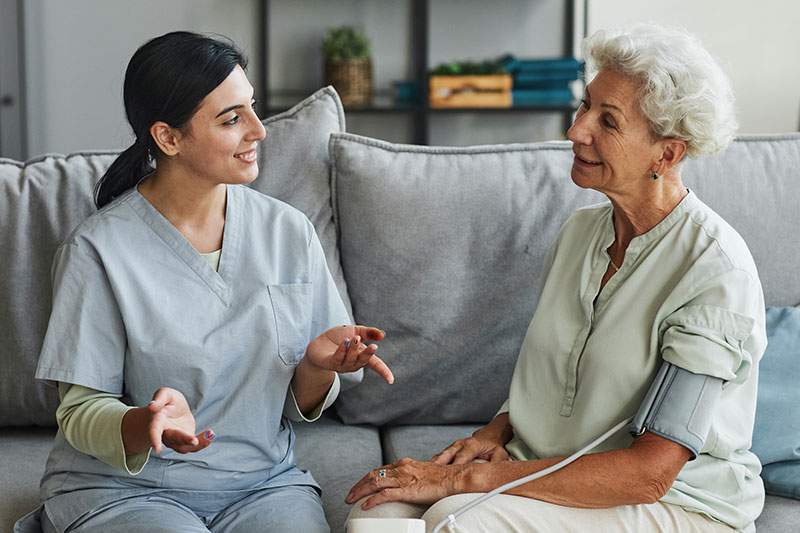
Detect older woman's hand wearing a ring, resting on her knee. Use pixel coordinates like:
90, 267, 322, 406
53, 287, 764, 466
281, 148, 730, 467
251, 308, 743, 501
345, 458, 468, 510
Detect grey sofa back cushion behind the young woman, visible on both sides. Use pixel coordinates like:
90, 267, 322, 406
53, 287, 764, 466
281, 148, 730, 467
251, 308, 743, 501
0, 87, 349, 427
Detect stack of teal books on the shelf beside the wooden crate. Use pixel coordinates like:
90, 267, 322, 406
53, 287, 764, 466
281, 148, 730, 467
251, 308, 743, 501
500, 55, 583, 107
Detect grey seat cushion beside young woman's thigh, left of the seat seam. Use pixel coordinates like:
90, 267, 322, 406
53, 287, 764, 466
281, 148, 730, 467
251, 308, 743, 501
294, 414, 382, 533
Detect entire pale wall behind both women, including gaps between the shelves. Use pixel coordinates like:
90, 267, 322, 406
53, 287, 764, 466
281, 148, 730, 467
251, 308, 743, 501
25, 0, 800, 156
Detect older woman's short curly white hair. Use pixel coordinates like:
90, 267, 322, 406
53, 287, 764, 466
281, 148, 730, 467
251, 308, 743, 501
583, 23, 738, 157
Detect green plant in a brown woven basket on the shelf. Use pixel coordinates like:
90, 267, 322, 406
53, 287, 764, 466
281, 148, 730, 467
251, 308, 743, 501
322, 26, 372, 106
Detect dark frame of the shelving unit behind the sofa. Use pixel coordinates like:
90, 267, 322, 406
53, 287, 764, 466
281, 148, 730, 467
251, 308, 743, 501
258, 0, 588, 145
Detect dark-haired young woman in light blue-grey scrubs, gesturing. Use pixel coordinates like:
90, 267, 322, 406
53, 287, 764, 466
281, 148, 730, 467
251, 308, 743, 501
29, 32, 393, 533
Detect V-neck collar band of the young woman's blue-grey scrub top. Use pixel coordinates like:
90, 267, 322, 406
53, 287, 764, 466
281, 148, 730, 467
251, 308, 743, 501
128, 185, 241, 306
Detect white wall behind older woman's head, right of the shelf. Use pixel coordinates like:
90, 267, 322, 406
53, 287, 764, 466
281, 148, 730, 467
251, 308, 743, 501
589, 0, 800, 133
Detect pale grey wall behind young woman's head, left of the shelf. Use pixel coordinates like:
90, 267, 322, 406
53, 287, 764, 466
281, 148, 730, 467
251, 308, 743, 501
25, 0, 259, 156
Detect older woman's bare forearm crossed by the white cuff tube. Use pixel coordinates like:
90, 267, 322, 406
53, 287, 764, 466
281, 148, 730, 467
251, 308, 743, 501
459, 449, 671, 508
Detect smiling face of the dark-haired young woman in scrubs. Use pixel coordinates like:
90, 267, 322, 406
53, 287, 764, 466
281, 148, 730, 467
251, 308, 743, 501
170, 66, 266, 184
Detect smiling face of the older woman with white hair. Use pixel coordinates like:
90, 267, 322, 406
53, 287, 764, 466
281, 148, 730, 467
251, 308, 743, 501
567, 70, 663, 194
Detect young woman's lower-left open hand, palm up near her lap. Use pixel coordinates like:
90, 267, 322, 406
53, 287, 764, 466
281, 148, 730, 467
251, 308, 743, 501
147, 387, 214, 454
